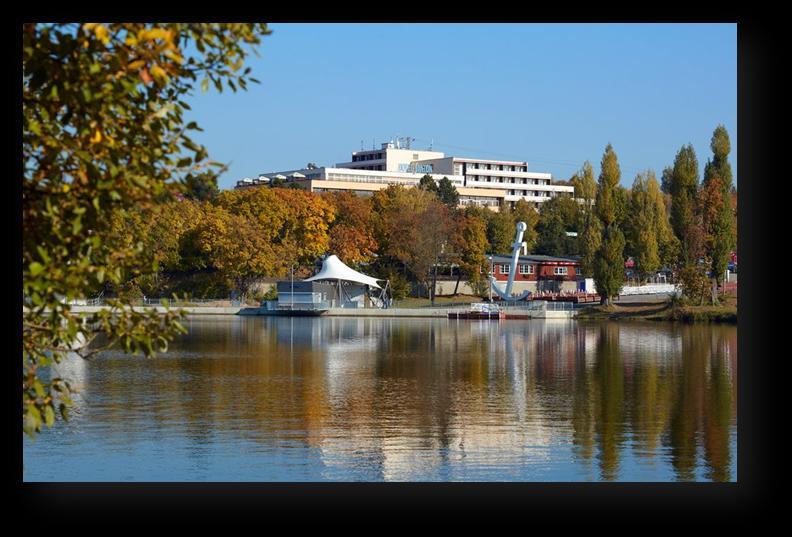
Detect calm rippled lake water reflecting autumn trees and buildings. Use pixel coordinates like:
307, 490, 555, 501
23, 316, 737, 481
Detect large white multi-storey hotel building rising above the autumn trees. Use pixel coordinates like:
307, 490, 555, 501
236, 142, 574, 210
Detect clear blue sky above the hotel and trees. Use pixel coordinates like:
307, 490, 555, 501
189, 23, 737, 188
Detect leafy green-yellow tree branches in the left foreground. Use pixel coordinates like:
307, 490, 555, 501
21, 23, 269, 435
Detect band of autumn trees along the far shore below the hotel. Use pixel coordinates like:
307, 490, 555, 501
97, 126, 737, 314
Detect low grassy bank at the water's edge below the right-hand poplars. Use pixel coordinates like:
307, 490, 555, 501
577, 296, 737, 324
